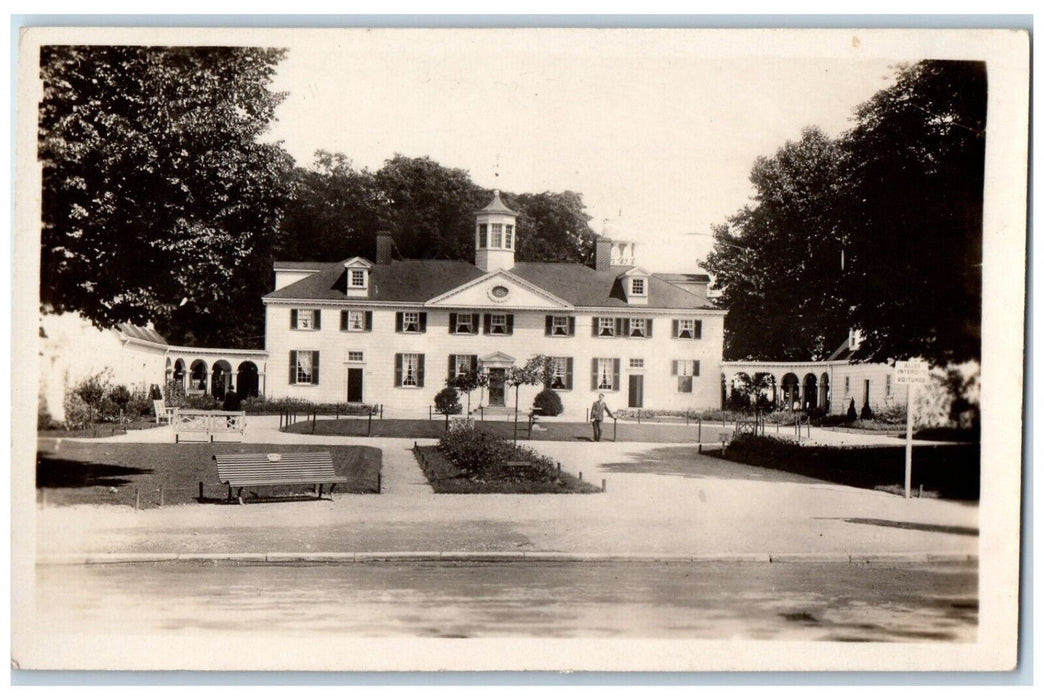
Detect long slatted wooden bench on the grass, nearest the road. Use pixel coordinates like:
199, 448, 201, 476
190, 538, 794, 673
214, 452, 348, 505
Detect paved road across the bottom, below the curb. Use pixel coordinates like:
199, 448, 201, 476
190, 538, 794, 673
35, 562, 978, 641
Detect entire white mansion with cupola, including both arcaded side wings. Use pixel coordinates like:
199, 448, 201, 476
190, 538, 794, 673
41, 192, 922, 419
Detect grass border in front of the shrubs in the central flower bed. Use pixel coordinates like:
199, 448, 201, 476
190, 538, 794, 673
414, 445, 601, 493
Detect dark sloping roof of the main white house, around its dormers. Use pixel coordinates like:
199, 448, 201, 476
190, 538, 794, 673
264, 260, 717, 310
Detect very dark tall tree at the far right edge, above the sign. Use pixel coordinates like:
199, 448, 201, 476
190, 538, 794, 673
844, 61, 987, 365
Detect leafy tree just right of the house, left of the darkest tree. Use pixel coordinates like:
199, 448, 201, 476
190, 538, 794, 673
705, 129, 848, 360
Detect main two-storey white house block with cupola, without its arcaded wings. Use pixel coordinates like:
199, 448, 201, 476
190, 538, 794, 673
264, 192, 726, 416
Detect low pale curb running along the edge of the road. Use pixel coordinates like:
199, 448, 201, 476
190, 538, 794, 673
35, 551, 978, 565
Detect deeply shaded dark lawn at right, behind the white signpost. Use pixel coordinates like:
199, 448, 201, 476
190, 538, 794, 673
704, 436, 980, 500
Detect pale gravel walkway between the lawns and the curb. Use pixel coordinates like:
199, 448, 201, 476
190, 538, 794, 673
37, 416, 978, 560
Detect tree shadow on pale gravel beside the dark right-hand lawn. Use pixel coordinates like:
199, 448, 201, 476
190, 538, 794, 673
599, 446, 822, 484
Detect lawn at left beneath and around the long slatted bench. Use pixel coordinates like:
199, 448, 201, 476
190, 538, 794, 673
37, 439, 381, 508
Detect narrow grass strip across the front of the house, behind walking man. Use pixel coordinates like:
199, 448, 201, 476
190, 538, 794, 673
286, 418, 720, 442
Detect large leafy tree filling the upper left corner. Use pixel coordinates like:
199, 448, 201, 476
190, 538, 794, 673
39, 46, 290, 344
